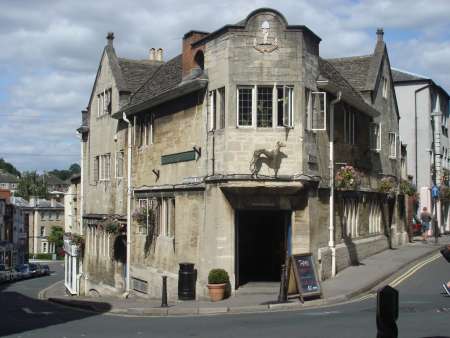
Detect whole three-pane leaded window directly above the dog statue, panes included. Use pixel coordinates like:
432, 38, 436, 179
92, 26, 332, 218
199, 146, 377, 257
237, 85, 294, 128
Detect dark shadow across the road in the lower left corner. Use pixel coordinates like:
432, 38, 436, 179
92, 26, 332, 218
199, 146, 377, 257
0, 284, 111, 337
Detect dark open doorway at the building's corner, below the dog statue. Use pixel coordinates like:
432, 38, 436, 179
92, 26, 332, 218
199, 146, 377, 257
236, 210, 289, 288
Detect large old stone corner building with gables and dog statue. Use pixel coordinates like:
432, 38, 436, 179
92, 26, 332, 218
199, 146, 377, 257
79, 8, 407, 298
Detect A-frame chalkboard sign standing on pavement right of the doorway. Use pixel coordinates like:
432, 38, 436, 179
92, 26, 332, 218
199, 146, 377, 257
287, 253, 322, 303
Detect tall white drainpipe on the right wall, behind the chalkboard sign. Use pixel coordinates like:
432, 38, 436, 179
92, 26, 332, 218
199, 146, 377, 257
328, 91, 342, 277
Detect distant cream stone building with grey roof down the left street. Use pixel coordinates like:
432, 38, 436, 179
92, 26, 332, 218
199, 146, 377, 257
25, 197, 64, 256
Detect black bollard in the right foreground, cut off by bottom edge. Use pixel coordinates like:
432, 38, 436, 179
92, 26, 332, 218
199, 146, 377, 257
377, 285, 398, 338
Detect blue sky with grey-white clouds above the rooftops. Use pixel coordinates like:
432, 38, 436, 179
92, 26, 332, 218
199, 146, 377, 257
0, 0, 450, 171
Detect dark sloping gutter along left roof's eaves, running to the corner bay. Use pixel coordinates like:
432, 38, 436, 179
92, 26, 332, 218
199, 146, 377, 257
112, 79, 208, 119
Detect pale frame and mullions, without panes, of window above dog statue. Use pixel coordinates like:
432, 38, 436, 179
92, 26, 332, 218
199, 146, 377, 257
236, 83, 295, 129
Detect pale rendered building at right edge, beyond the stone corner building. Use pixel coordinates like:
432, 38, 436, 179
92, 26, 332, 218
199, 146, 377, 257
393, 69, 450, 232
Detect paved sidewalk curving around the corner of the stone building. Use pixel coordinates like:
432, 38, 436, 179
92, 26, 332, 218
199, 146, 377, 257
39, 236, 450, 316
